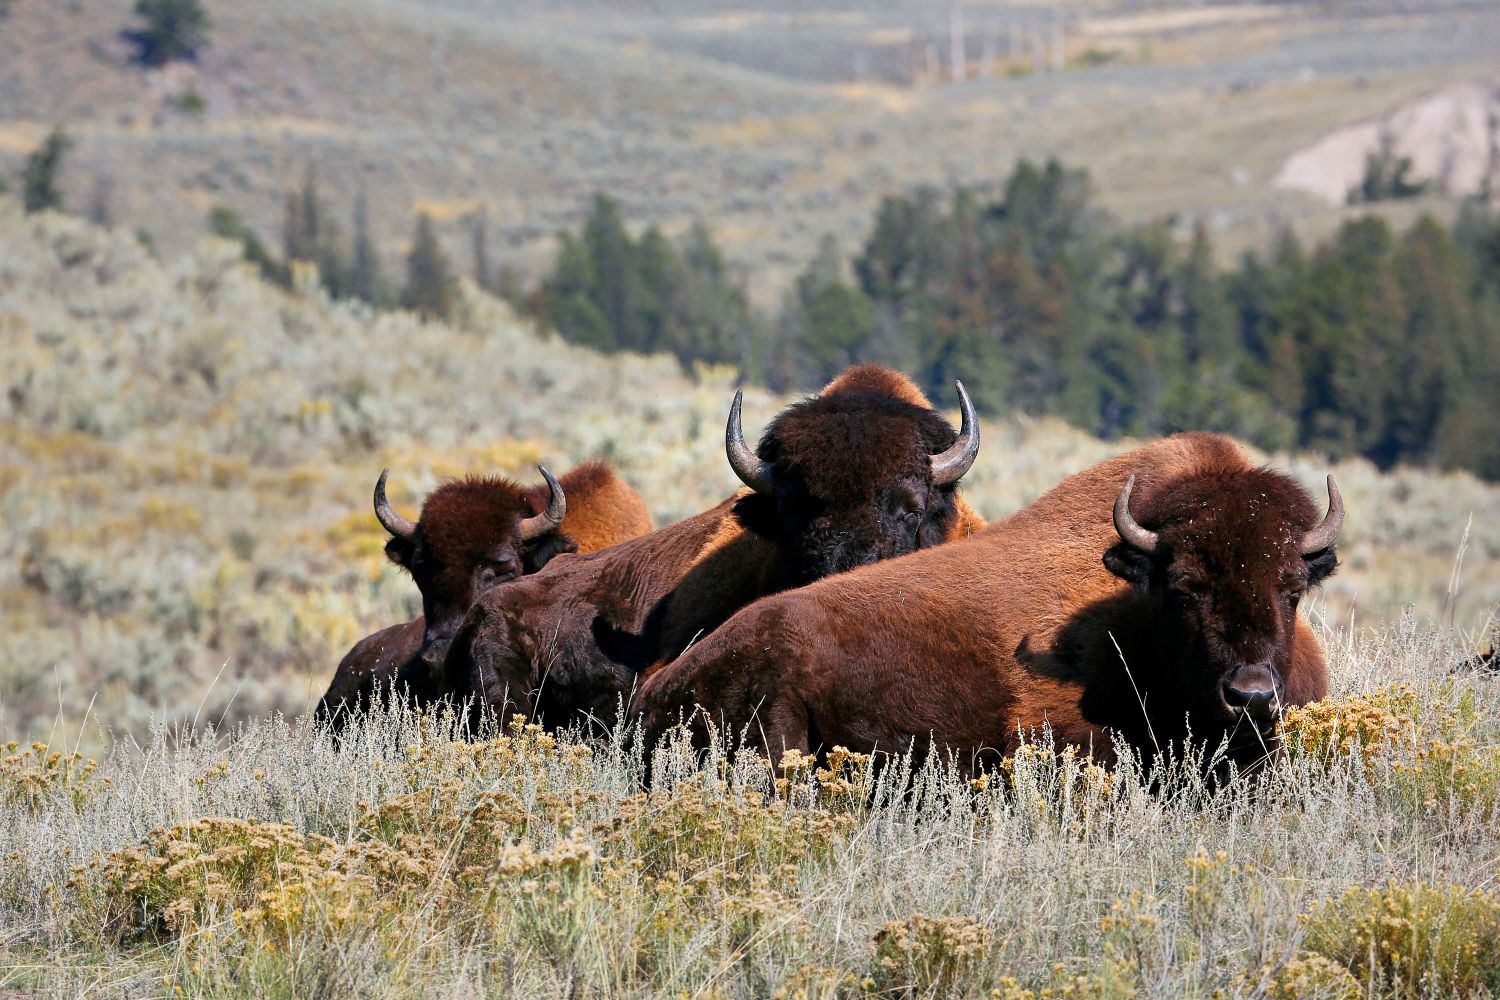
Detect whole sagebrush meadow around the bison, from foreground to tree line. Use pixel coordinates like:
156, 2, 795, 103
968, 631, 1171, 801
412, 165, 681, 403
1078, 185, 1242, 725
0, 198, 1500, 1000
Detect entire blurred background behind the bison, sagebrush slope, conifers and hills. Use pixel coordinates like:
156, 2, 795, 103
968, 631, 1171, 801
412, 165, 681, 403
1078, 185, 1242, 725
0, 0, 1500, 735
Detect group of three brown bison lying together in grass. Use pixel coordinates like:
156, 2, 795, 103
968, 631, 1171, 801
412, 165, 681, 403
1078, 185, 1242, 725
317, 366, 1344, 769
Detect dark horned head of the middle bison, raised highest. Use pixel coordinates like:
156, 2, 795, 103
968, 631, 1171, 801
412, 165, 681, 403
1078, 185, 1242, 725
725, 382, 980, 585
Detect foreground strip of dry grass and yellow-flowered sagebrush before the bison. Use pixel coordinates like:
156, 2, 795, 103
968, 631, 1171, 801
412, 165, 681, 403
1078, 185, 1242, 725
0, 625, 1500, 1000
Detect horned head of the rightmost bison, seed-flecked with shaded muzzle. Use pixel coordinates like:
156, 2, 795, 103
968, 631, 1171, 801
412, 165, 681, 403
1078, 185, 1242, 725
1104, 469, 1344, 742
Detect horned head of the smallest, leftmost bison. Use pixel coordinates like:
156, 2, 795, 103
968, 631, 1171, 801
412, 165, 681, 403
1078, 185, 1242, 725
375, 466, 578, 669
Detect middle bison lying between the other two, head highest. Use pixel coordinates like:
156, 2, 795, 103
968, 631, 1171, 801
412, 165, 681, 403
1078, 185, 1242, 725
443, 366, 983, 726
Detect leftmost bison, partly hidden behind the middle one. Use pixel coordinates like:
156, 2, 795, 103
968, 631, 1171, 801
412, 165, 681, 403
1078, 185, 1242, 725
315, 462, 651, 720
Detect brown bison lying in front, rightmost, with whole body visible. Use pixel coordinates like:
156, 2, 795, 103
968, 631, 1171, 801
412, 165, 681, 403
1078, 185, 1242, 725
633, 433, 1344, 766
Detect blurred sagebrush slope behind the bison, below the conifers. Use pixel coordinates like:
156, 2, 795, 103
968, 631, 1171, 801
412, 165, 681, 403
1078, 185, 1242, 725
0, 199, 1500, 739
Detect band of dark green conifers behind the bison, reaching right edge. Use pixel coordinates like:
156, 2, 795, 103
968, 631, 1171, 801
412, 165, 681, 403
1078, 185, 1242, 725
525, 160, 1500, 480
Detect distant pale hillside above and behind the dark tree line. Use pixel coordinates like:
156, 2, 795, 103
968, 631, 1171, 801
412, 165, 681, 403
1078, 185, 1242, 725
0, 0, 1500, 301
